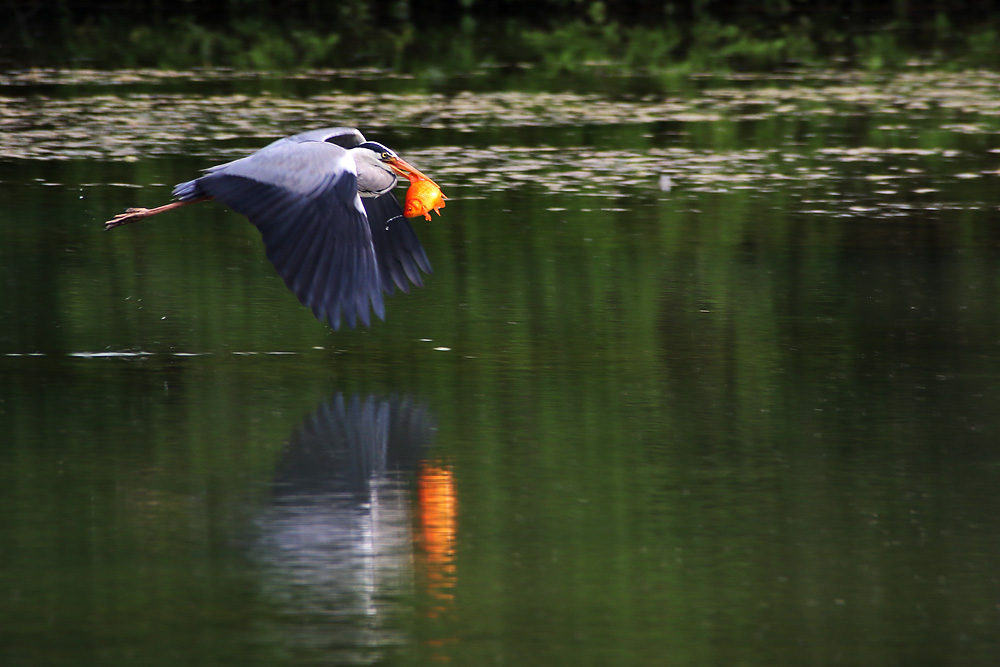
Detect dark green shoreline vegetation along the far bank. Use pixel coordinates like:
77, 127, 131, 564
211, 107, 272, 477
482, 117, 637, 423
0, 0, 1000, 74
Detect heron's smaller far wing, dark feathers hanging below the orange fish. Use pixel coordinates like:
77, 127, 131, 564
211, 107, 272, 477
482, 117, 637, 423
361, 192, 431, 295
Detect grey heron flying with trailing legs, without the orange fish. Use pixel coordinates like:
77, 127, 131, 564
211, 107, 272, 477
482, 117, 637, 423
104, 127, 431, 329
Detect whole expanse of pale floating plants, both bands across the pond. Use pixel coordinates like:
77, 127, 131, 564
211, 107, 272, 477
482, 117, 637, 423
0, 70, 1000, 214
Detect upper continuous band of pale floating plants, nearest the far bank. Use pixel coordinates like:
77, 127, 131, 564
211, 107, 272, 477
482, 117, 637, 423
0, 70, 1000, 160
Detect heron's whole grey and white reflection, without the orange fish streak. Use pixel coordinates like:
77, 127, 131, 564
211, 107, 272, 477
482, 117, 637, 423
254, 395, 442, 664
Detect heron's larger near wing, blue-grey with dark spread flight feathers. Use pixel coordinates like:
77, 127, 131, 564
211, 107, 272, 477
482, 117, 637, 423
174, 141, 385, 329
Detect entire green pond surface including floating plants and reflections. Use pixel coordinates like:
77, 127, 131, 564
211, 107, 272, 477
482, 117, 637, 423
0, 73, 1000, 665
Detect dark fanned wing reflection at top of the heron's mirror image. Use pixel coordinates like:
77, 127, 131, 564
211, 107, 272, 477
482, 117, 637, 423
274, 394, 433, 499
